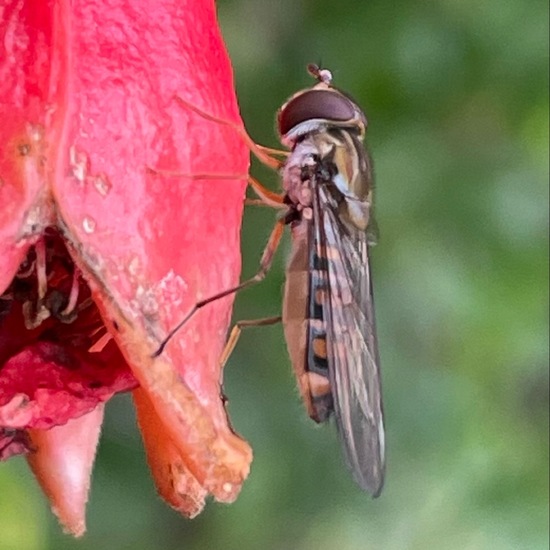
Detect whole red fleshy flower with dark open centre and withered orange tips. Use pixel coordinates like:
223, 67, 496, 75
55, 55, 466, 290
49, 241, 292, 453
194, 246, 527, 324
0, 0, 251, 535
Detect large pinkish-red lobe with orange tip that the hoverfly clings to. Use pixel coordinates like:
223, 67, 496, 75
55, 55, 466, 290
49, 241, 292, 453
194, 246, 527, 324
48, 2, 251, 501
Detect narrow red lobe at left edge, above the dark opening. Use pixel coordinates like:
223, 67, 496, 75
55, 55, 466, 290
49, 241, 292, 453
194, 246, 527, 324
0, 0, 53, 293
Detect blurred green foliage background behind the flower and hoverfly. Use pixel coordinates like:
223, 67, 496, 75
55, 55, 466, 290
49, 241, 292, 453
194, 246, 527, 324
0, 0, 549, 550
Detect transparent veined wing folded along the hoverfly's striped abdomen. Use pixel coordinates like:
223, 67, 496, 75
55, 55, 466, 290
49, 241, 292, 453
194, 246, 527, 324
313, 185, 384, 496
